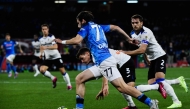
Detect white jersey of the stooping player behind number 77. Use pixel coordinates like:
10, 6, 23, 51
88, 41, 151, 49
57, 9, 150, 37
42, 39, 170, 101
109, 49, 131, 67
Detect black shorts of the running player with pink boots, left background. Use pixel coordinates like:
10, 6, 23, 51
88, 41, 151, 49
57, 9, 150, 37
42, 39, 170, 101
42, 58, 64, 68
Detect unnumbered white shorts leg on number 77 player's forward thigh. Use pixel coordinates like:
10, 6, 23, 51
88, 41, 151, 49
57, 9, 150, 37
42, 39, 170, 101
88, 65, 102, 79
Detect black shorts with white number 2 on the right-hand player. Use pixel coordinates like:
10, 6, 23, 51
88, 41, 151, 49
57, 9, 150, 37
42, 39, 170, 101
148, 55, 167, 80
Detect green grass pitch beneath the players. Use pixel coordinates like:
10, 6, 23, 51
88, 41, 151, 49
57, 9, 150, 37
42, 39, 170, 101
0, 68, 190, 109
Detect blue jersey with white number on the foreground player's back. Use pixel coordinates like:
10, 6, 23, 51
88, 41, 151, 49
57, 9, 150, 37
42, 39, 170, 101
78, 22, 111, 65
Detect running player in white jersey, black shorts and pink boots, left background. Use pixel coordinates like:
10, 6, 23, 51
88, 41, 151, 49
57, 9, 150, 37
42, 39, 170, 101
39, 24, 72, 90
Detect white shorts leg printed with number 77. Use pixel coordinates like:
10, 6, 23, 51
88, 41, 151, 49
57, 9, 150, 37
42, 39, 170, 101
99, 56, 122, 82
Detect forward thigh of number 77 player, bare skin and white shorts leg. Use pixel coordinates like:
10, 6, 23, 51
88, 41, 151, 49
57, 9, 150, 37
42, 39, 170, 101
75, 66, 102, 83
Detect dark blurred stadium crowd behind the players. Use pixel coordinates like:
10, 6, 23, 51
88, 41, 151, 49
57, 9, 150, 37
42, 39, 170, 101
0, 1, 190, 71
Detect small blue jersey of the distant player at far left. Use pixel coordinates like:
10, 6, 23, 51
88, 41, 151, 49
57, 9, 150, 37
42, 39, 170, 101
2, 40, 17, 57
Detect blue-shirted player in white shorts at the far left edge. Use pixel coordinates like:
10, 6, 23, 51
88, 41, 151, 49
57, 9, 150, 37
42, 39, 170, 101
1, 33, 23, 78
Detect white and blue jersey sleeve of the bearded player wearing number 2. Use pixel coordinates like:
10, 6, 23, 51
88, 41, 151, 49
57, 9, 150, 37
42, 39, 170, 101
141, 32, 151, 45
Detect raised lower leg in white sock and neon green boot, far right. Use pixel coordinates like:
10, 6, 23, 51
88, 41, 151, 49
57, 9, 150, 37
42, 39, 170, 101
165, 76, 188, 92
